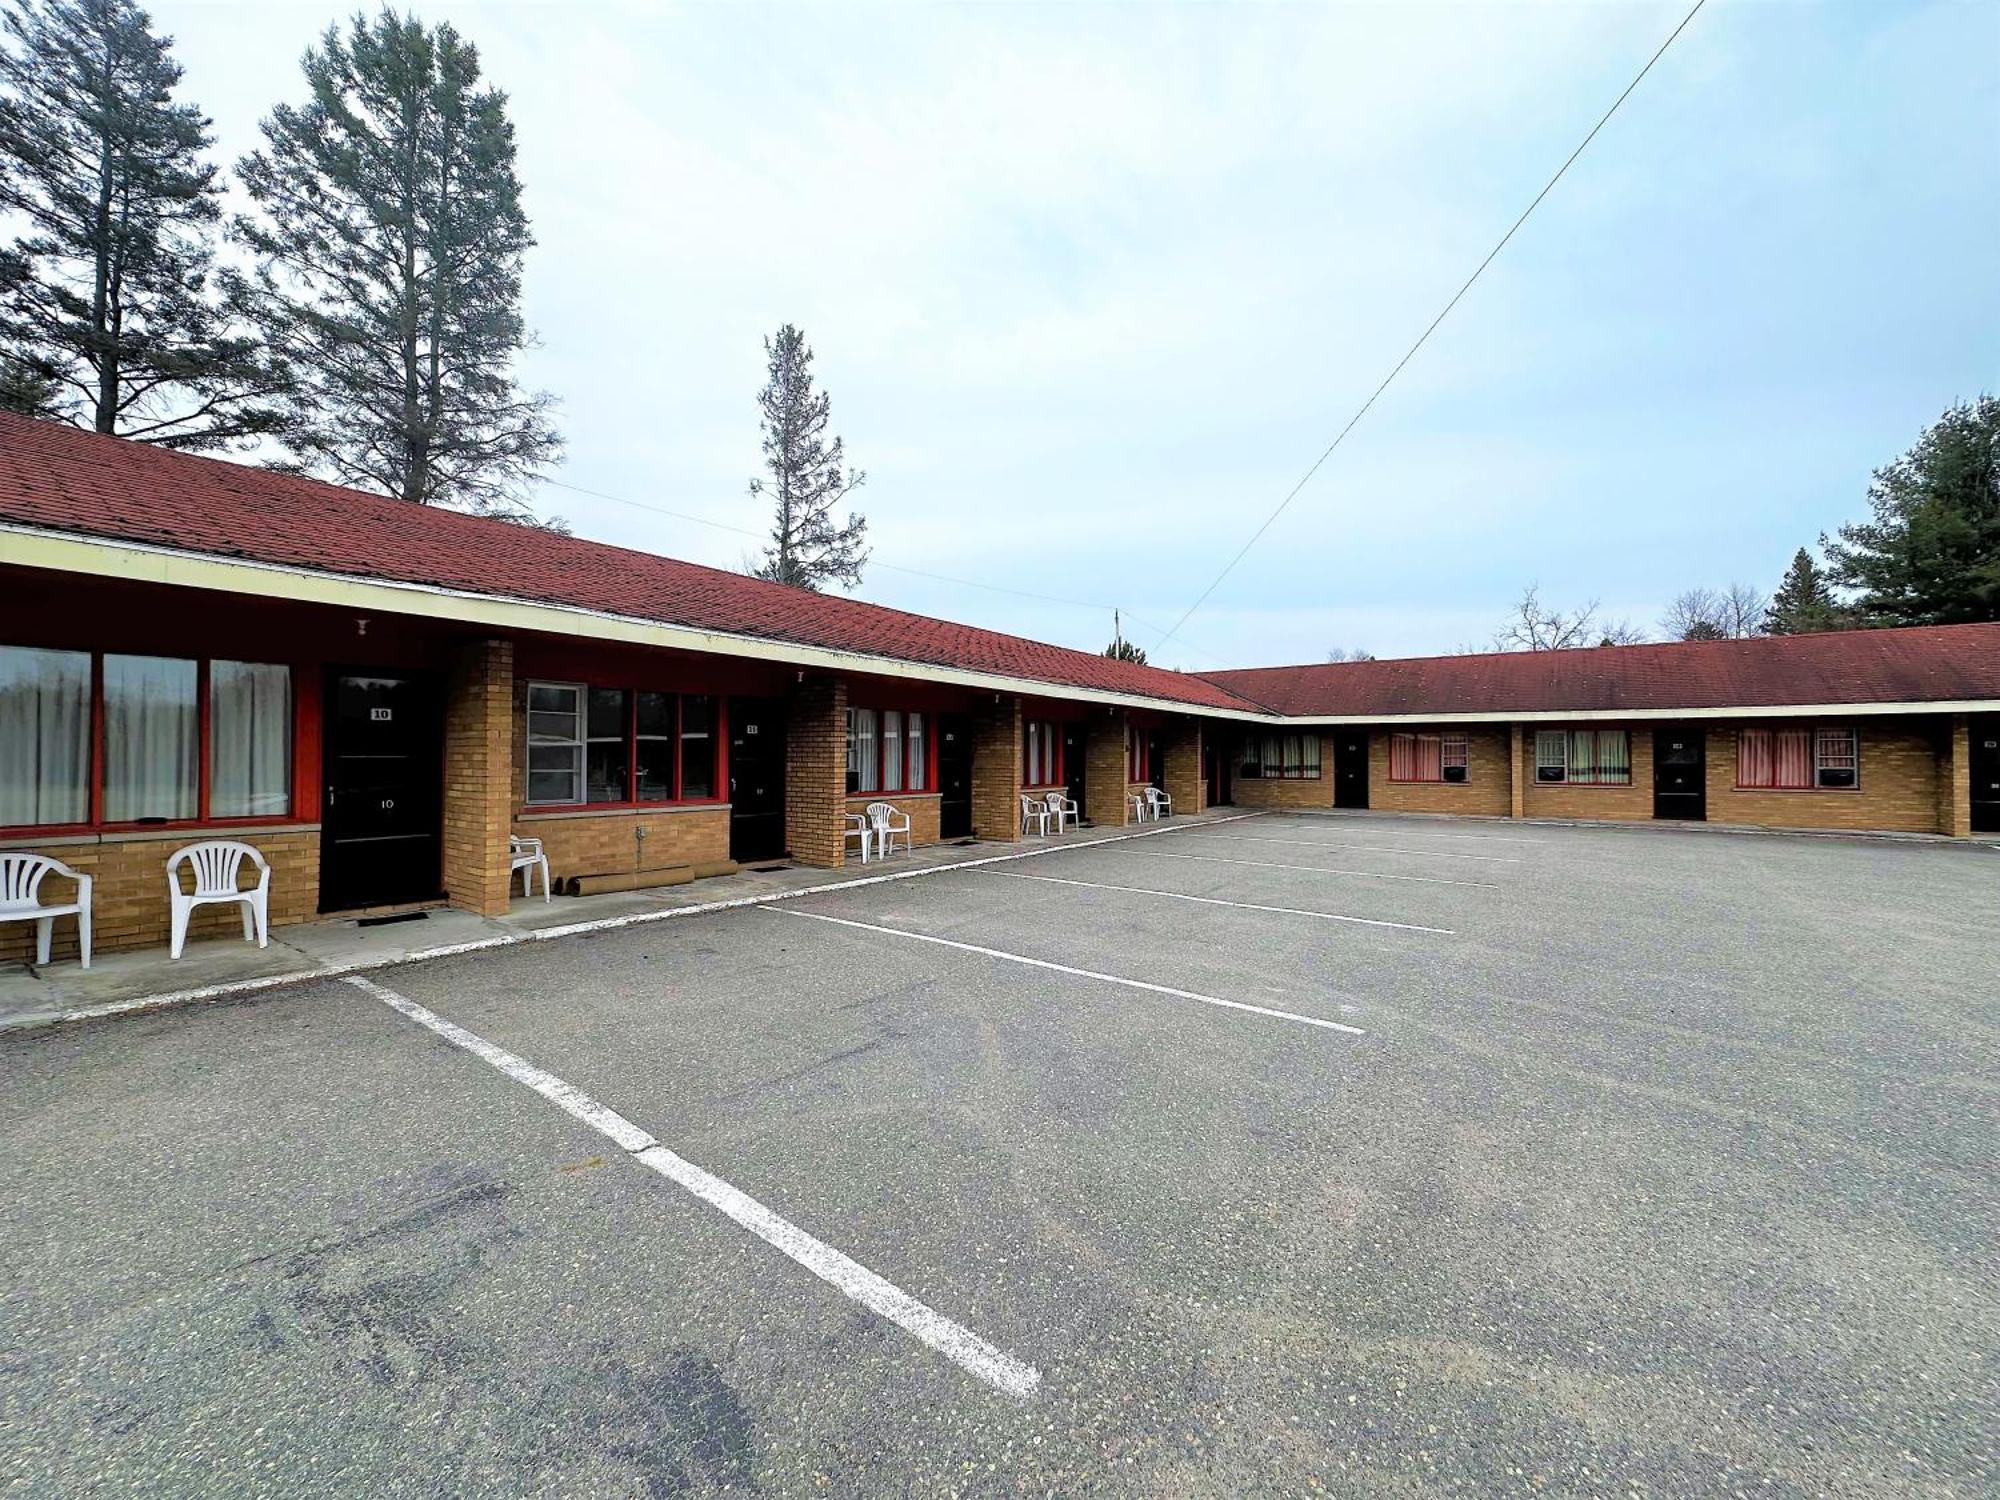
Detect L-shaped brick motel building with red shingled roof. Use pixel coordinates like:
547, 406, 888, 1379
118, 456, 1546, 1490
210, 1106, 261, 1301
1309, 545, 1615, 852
0, 414, 2000, 962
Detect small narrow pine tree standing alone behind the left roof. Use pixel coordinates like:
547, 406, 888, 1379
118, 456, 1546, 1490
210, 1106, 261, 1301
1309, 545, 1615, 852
750, 324, 868, 590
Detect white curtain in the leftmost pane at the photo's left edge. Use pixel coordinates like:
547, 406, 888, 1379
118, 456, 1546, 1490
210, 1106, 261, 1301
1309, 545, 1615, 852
0, 646, 90, 828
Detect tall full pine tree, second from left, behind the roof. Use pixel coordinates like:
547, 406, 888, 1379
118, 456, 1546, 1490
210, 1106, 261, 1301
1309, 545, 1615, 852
236, 10, 562, 520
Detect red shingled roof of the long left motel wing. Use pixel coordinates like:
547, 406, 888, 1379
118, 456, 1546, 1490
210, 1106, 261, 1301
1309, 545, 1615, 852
0, 412, 1256, 710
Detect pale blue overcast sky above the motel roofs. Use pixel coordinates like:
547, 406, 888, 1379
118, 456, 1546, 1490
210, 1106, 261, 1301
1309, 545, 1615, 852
152, 0, 2000, 668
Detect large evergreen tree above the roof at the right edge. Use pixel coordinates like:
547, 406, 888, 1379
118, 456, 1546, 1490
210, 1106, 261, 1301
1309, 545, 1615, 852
1822, 396, 2000, 626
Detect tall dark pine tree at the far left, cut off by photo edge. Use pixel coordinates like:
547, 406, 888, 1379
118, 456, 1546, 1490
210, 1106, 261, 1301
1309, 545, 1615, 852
0, 0, 278, 450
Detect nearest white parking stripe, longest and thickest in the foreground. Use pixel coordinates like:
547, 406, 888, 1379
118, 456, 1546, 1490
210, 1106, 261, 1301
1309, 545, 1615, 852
346, 974, 1042, 1400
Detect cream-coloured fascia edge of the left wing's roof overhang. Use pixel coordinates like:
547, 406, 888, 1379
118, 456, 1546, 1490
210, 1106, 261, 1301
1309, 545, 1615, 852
0, 522, 1282, 724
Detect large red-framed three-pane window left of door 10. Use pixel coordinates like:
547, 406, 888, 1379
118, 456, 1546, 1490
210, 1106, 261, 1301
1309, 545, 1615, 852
0, 646, 292, 828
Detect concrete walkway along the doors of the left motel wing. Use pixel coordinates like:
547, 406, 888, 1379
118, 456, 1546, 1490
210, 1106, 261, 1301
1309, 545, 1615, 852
0, 808, 1244, 1032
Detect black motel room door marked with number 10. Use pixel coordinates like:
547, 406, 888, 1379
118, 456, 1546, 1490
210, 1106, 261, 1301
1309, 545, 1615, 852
320, 670, 444, 912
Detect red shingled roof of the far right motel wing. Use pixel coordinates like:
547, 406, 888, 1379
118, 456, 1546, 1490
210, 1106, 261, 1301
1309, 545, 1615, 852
1204, 624, 2000, 716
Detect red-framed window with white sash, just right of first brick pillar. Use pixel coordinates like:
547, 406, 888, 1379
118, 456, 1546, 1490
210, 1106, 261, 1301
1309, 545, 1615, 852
528, 682, 718, 806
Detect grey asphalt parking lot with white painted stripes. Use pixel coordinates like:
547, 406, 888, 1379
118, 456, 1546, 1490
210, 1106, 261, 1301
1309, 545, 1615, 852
0, 816, 2000, 1496
